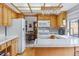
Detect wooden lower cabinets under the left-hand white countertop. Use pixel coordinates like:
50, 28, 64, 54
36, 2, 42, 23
0, 38, 18, 56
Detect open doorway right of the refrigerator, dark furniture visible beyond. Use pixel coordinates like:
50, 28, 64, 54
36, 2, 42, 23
25, 16, 37, 47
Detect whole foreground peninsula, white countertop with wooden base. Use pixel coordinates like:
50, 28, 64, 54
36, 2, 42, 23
32, 36, 79, 56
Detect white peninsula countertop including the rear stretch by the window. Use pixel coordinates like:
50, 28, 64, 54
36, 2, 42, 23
33, 34, 79, 47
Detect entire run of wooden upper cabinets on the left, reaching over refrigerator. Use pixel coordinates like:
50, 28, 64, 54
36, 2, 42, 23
0, 3, 22, 26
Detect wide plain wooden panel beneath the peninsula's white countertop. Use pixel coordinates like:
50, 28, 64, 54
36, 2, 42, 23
33, 47, 74, 56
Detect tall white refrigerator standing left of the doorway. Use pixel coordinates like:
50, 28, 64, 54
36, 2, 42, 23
7, 18, 26, 53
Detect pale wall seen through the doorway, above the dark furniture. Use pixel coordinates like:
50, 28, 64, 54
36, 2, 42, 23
25, 16, 37, 31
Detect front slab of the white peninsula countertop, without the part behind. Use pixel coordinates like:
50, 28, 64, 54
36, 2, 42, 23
34, 39, 79, 47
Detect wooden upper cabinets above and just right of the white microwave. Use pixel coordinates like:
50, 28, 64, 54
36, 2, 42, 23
38, 14, 57, 28
